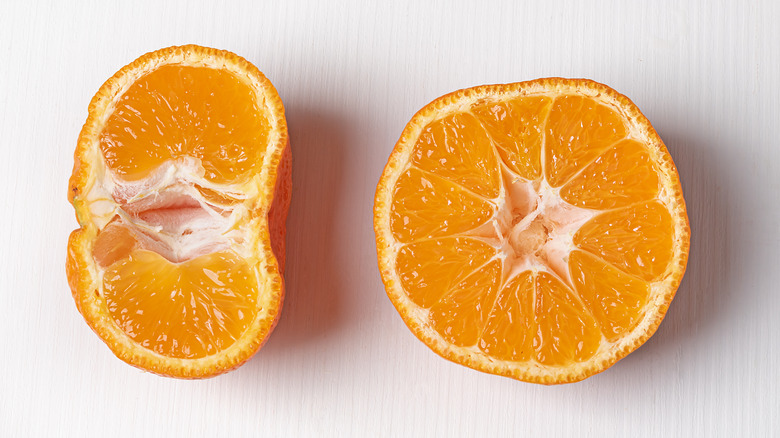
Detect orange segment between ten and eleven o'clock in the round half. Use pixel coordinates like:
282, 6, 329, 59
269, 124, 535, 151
411, 113, 500, 199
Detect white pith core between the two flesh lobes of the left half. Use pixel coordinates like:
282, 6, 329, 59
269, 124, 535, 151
87, 157, 247, 263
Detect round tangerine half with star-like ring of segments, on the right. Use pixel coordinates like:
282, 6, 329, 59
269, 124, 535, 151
374, 78, 690, 384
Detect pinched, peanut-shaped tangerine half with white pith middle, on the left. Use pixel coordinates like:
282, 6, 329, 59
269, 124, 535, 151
67, 46, 291, 378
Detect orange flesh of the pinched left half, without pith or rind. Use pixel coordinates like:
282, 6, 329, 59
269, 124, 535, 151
93, 65, 270, 359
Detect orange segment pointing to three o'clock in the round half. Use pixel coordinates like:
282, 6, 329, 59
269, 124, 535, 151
574, 201, 674, 281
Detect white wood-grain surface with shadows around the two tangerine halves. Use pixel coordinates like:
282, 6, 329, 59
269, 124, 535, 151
0, 0, 780, 438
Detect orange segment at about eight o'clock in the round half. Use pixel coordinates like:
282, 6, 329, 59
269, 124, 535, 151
396, 237, 496, 308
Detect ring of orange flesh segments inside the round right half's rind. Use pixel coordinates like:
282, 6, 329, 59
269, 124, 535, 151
390, 95, 674, 366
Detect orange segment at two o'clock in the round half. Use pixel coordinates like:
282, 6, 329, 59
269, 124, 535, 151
561, 139, 659, 210
